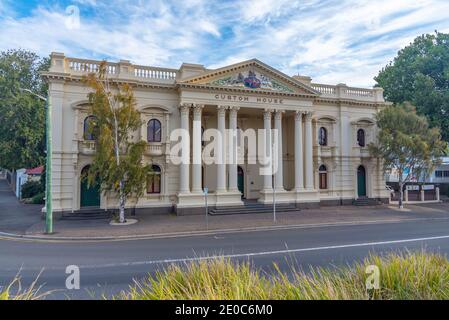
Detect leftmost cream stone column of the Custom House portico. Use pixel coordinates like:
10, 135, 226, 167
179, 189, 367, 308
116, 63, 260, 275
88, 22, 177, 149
179, 104, 190, 194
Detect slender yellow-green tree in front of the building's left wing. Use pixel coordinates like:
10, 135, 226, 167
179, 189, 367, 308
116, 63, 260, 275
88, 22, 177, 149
81, 62, 151, 223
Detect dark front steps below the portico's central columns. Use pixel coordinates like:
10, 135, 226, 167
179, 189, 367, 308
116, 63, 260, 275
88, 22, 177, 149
209, 200, 300, 216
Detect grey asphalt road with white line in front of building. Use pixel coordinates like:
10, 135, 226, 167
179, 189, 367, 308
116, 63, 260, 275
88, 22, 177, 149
0, 219, 449, 299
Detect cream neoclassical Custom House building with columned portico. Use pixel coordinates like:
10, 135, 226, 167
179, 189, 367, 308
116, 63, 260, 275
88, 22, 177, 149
44, 53, 389, 214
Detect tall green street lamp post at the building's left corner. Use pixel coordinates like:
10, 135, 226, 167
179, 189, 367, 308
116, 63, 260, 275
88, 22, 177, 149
20, 89, 53, 234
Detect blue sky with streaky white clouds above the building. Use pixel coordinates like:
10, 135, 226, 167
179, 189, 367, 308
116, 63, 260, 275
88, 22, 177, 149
0, 0, 449, 87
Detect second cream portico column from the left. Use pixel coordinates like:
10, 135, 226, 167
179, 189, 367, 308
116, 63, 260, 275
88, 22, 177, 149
192, 104, 204, 193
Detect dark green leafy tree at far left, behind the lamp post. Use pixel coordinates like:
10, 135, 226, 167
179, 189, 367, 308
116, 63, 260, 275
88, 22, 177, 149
0, 50, 50, 170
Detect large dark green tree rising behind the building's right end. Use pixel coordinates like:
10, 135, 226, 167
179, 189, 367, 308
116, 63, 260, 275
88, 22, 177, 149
375, 32, 449, 141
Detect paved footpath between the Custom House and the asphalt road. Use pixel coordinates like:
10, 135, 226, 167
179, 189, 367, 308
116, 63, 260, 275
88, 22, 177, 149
0, 180, 449, 240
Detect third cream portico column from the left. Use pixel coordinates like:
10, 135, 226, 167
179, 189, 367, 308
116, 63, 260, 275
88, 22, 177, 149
216, 106, 227, 193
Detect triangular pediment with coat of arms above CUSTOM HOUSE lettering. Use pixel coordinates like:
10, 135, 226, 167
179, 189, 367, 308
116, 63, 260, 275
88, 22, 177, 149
180, 59, 319, 95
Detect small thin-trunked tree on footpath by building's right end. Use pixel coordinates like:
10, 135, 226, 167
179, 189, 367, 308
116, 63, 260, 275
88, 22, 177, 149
369, 104, 448, 208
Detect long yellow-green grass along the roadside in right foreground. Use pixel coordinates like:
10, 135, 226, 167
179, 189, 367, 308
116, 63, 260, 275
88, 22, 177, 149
116, 252, 449, 300
